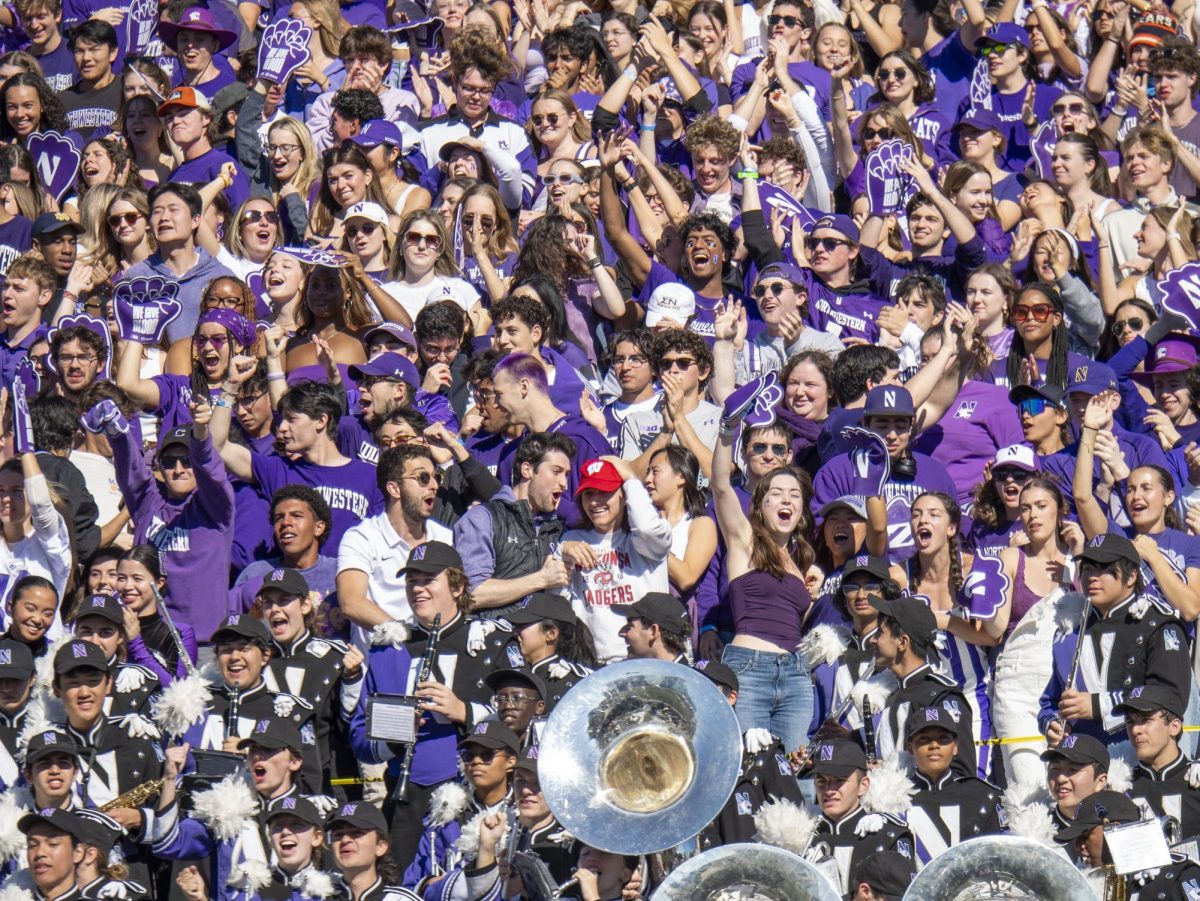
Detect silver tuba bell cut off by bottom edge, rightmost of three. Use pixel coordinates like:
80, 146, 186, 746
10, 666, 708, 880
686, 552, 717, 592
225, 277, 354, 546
904, 835, 1096, 901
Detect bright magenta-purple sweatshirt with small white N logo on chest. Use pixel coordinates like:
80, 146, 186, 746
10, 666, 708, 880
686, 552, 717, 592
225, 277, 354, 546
913, 380, 1025, 505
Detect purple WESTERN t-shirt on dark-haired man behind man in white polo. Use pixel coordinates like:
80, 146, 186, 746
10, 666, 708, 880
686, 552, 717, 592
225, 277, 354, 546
251, 453, 384, 557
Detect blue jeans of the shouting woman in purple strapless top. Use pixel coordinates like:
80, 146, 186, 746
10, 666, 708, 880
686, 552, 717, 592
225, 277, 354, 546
721, 644, 812, 751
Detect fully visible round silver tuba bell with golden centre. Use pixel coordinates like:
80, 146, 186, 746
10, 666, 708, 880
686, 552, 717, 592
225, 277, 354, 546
538, 660, 742, 855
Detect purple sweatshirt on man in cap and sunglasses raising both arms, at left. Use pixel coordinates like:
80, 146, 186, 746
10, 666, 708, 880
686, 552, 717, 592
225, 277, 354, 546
109, 434, 234, 642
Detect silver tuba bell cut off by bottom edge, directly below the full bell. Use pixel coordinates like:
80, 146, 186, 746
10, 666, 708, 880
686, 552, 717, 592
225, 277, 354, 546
650, 845, 841, 901
